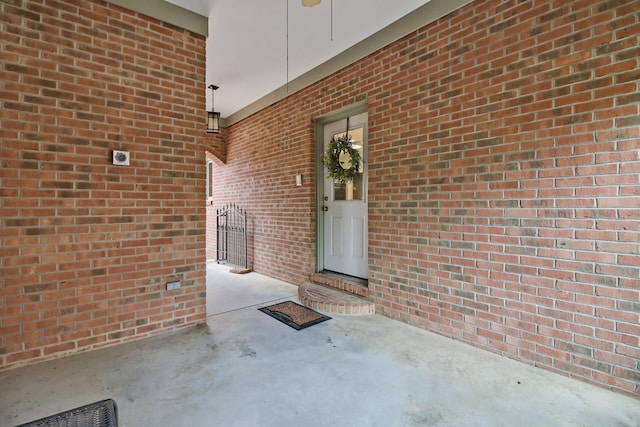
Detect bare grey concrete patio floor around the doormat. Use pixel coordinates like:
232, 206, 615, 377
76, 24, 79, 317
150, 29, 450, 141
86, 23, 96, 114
0, 264, 640, 427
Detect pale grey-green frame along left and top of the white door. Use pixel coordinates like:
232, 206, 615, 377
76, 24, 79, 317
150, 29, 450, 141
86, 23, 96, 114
314, 101, 368, 278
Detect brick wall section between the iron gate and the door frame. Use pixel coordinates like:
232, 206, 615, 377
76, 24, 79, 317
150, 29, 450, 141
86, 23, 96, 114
213, 107, 315, 284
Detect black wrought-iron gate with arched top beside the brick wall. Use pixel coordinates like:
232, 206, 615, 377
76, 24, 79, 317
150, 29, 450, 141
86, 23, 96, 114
216, 205, 248, 268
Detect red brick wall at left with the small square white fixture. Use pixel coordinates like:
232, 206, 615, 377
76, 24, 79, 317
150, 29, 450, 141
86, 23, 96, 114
0, 0, 206, 368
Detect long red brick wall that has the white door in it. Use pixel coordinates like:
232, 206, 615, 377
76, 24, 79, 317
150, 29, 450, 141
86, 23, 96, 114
216, 0, 640, 395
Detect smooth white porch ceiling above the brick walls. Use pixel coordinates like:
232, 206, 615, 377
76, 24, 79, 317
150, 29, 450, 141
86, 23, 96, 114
167, 0, 429, 117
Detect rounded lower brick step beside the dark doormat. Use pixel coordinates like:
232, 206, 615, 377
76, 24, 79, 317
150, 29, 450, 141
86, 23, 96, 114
298, 283, 376, 316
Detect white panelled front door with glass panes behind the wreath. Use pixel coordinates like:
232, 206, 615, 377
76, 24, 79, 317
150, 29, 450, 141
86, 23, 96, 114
323, 113, 369, 279
